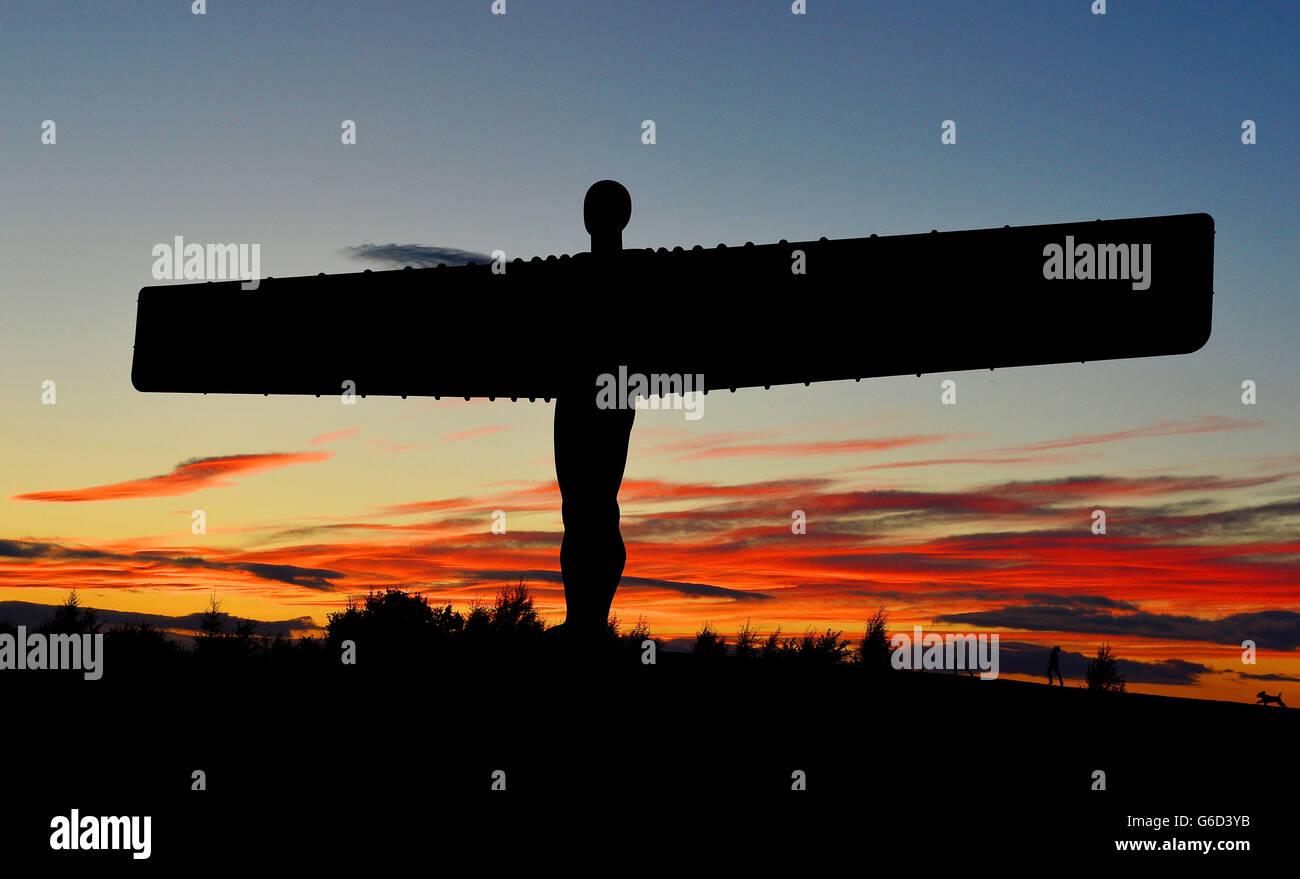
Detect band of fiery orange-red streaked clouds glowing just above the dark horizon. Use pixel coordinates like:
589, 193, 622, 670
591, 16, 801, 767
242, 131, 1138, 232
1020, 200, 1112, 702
0, 457, 1300, 694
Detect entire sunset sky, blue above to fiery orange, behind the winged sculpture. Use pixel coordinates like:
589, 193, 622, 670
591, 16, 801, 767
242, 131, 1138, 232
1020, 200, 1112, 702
0, 0, 1300, 701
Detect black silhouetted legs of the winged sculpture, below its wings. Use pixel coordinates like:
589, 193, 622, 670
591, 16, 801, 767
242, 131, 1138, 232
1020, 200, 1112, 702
555, 385, 636, 637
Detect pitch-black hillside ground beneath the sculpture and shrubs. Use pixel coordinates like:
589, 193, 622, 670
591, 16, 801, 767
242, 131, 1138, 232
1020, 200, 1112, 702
0, 653, 1300, 875
